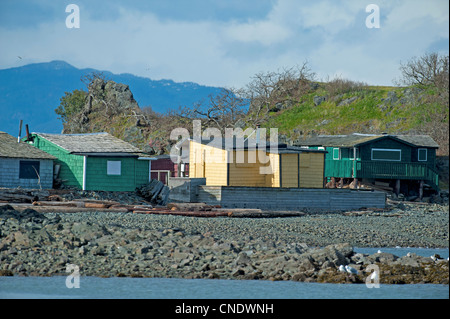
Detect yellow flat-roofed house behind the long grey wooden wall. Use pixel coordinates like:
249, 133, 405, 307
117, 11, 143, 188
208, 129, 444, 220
189, 139, 326, 188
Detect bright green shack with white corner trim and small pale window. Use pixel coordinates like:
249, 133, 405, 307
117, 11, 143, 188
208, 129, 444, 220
27, 133, 151, 191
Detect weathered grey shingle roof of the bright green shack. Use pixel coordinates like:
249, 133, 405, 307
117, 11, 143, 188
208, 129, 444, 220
33, 133, 142, 156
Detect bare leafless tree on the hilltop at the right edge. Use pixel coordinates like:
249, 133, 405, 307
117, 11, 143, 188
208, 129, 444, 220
400, 53, 449, 90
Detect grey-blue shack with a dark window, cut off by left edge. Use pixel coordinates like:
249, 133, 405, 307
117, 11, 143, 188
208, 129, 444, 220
0, 132, 56, 189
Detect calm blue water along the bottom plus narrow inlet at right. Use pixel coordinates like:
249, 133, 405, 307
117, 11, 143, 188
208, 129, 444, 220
0, 248, 449, 299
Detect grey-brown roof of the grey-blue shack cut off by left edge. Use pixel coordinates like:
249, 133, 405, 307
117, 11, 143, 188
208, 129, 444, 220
0, 132, 56, 160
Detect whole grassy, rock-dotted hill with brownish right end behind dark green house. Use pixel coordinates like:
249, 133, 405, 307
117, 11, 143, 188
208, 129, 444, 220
263, 83, 449, 156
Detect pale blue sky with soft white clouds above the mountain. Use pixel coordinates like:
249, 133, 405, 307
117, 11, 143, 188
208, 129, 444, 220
0, 0, 449, 88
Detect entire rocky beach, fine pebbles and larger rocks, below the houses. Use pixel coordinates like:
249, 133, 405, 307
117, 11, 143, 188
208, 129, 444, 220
0, 192, 449, 284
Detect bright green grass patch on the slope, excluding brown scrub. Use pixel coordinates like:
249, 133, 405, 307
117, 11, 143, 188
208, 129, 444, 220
264, 86, 448, 138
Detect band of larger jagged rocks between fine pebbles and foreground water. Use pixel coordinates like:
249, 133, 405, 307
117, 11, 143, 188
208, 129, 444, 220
0, 205, 448, 284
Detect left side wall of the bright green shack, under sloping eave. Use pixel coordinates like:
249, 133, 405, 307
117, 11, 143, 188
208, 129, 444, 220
33, 135, 84, 188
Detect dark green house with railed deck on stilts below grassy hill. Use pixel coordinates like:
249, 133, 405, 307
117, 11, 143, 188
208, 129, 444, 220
296, 133, 439, 191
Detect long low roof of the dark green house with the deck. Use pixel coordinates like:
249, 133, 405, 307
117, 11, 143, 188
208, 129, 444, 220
296, 133, 439, 148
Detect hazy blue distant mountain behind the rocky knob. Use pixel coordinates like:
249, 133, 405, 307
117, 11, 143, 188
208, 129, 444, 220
0, 61, 220, 136
